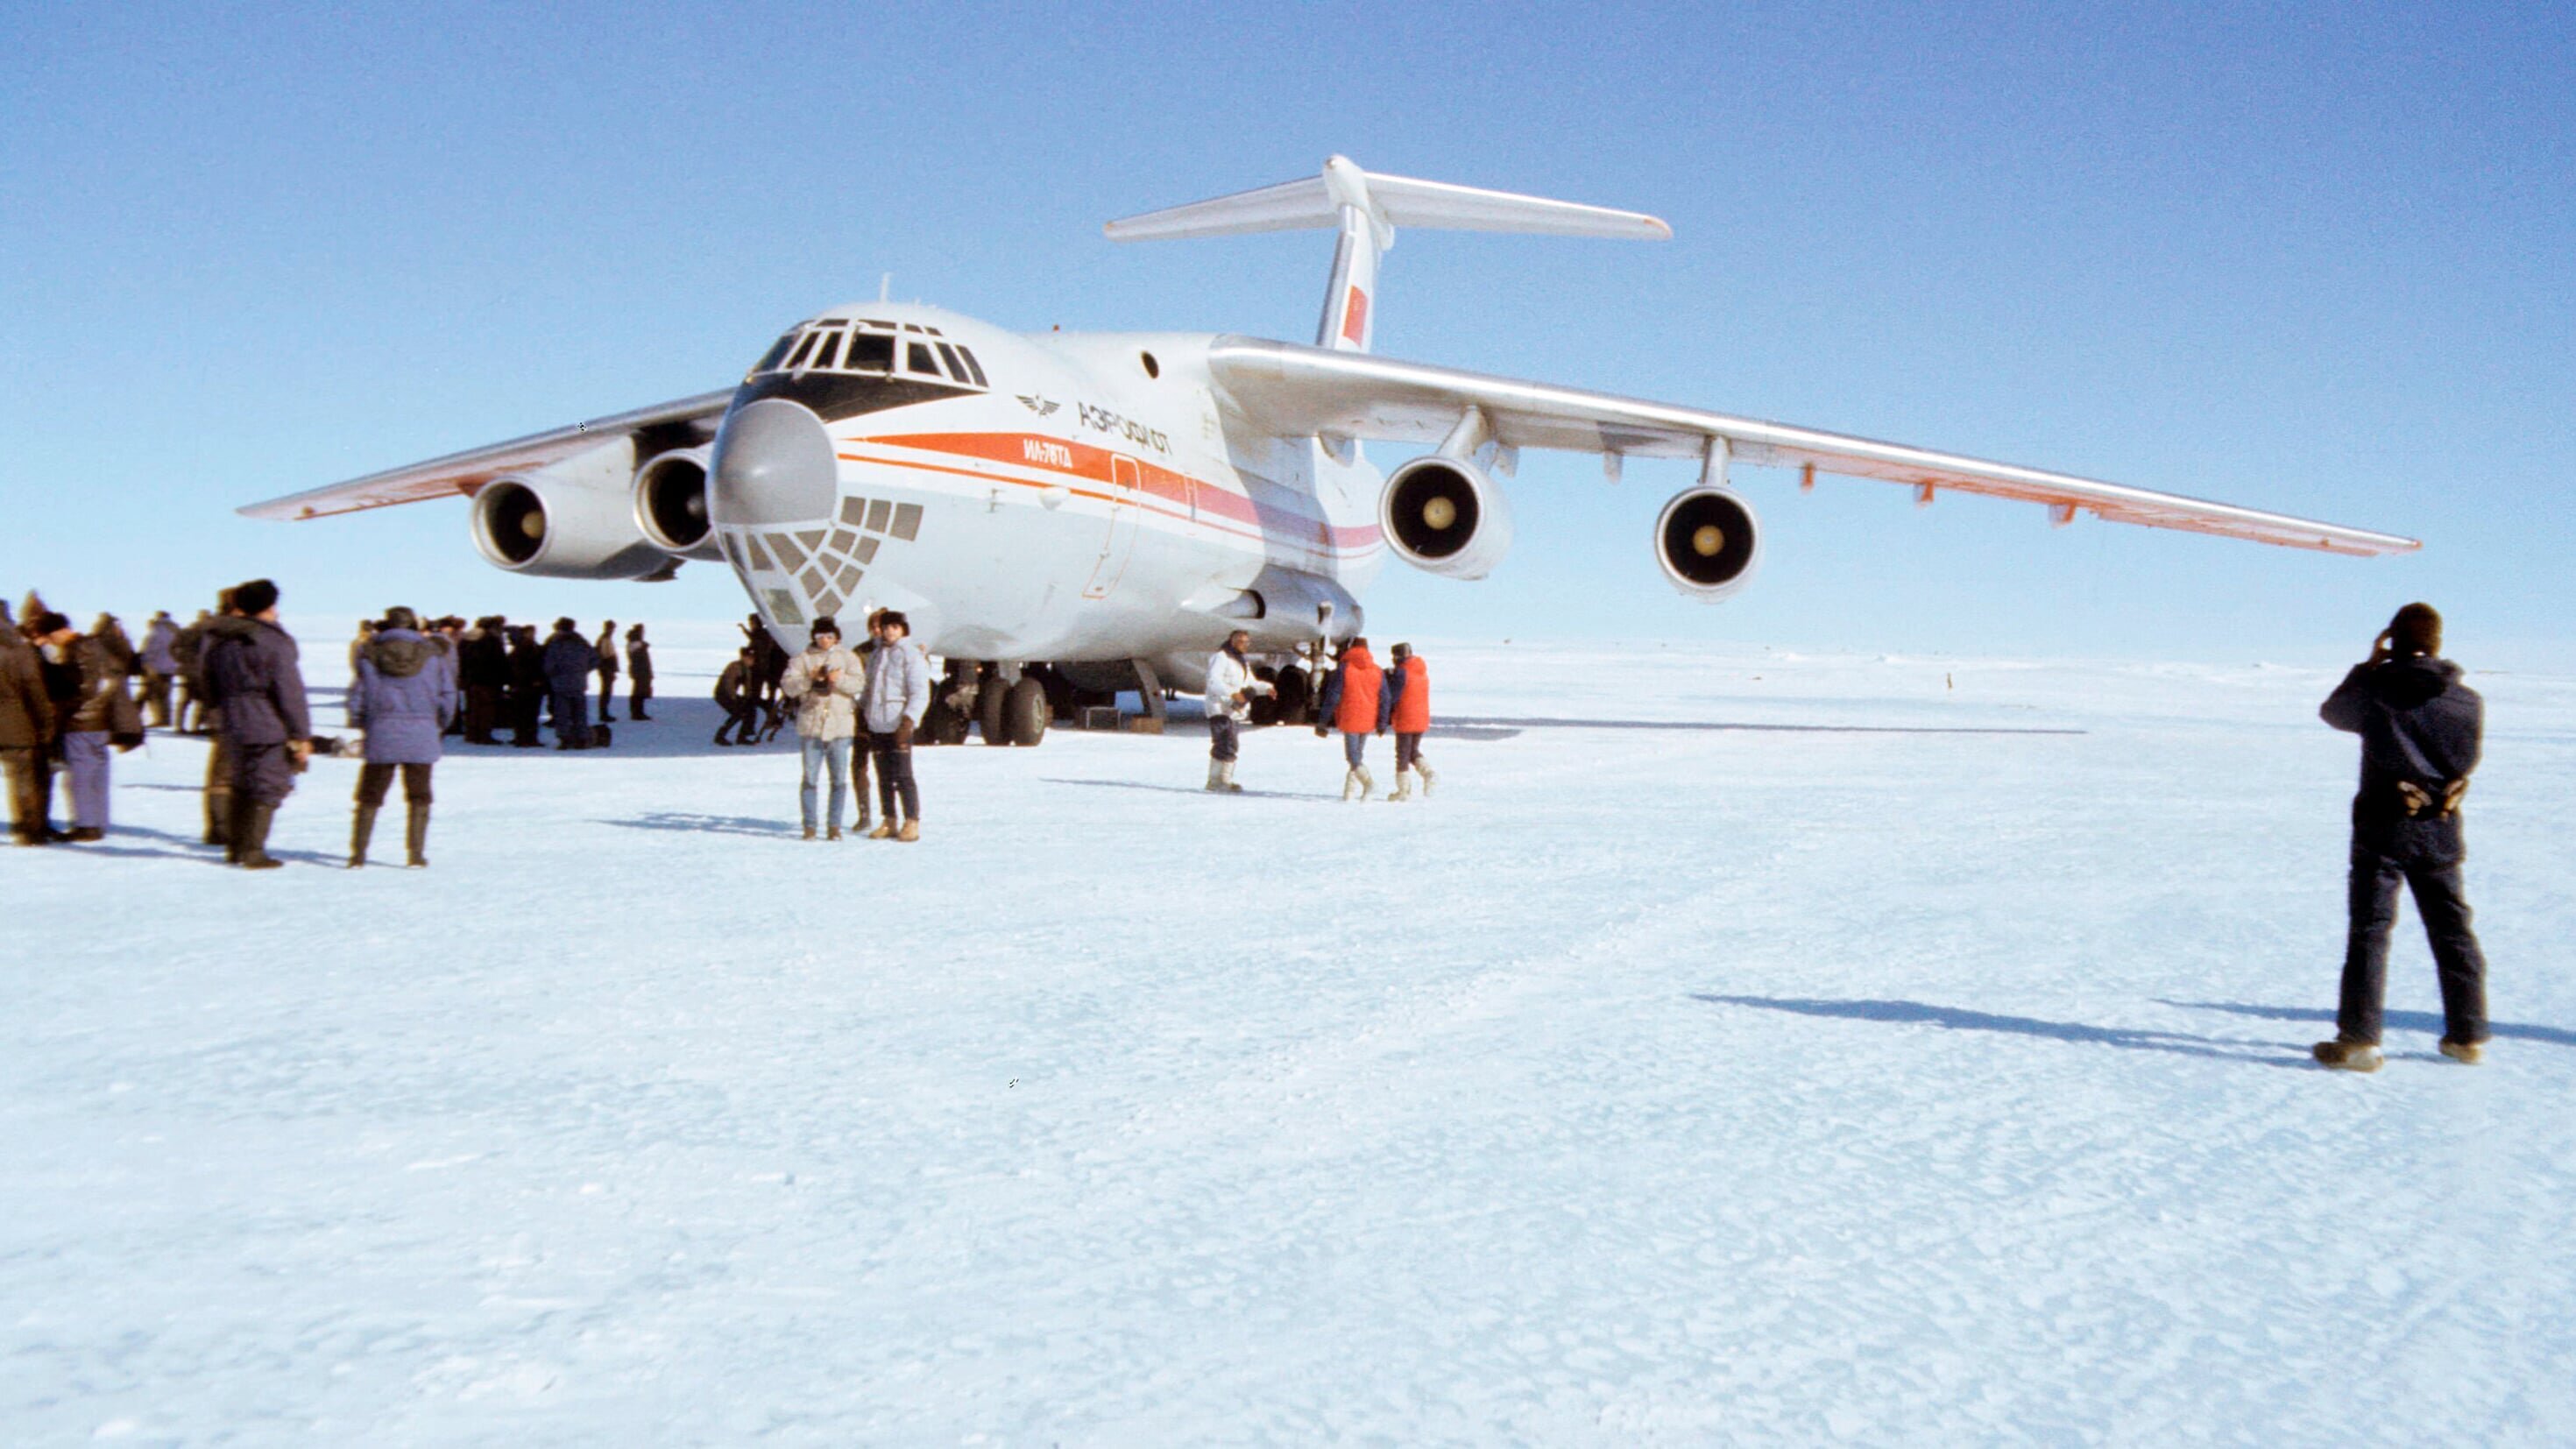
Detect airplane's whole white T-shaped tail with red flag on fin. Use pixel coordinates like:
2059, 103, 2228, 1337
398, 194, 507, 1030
1105, 157, 1672, 352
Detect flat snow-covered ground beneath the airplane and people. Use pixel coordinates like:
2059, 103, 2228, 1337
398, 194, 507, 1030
0, 631, 2576, 1444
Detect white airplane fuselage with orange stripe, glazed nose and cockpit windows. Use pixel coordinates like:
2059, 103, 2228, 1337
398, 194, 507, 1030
709, 304, 1386, 669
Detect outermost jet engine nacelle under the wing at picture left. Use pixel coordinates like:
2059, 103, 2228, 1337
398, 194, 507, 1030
474, 437, 669, 579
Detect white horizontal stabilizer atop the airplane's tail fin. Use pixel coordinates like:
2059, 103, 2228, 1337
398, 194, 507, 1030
1105, 157, 1672, 242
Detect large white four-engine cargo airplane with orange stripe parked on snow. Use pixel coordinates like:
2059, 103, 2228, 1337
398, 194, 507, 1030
242, 157, 2417, 744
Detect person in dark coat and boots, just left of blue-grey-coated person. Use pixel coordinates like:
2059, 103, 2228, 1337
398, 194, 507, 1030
206, 579, 315, 870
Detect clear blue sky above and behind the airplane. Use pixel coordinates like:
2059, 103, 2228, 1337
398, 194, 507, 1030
0, 3, 2576, 667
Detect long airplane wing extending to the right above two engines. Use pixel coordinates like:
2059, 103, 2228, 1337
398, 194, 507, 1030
1208, 337, 2422, 556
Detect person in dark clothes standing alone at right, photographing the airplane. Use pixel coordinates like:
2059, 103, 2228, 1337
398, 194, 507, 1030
2316, 604, 2488, 1071
